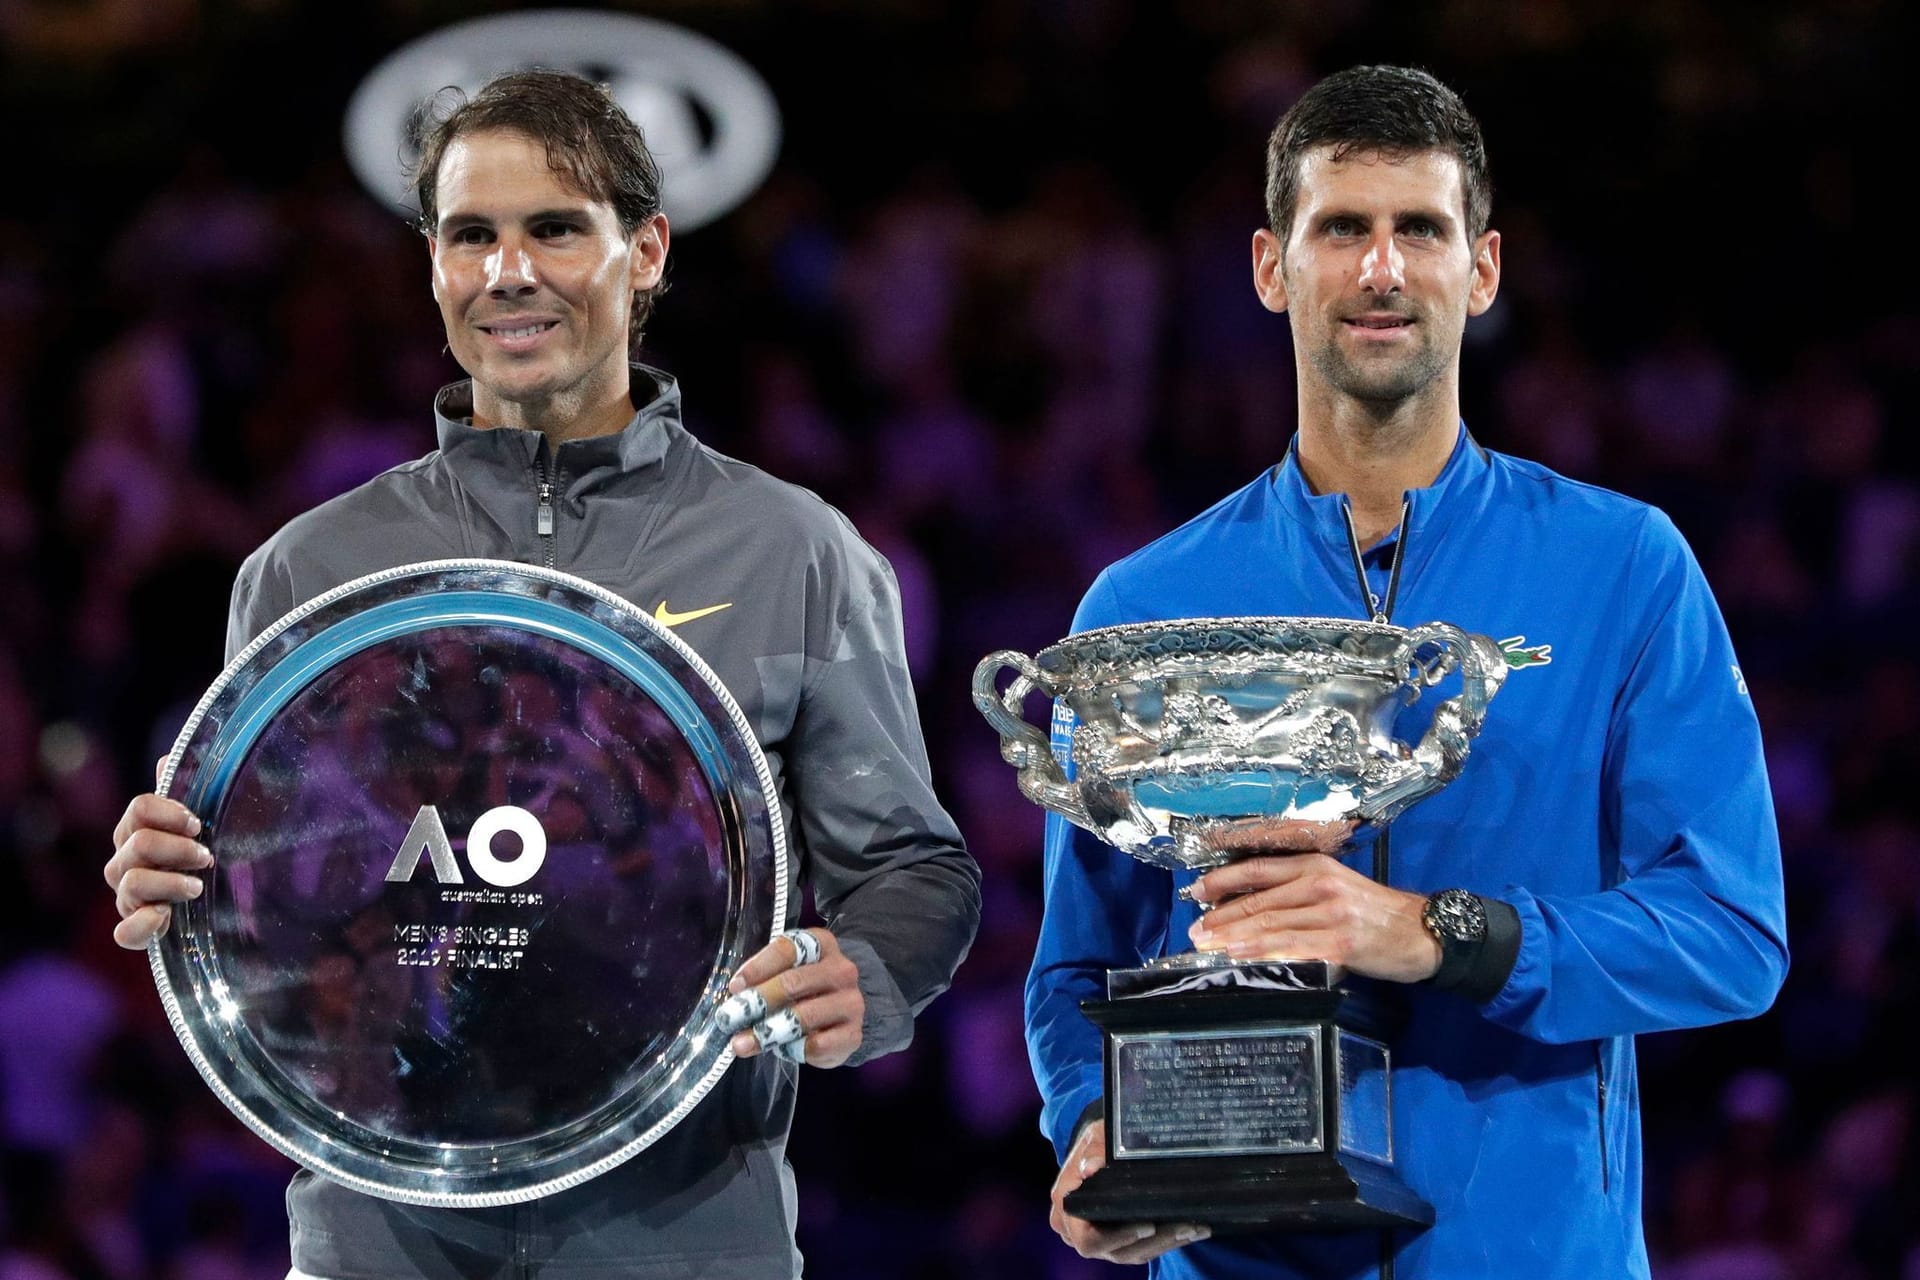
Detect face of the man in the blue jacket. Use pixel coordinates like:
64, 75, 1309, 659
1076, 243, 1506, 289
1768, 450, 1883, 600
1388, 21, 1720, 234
1254, 146, 1500, 409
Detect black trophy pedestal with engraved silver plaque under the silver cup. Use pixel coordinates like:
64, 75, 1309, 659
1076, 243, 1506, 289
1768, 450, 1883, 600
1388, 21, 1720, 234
1066, 961, 1434, 1232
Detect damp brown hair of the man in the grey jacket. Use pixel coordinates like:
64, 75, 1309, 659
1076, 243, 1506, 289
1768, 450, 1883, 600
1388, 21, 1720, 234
407, 69, 666, 347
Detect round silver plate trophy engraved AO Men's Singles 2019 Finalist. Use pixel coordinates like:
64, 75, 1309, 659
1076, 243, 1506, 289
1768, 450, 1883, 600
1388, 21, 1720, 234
150, 560, 787, 1207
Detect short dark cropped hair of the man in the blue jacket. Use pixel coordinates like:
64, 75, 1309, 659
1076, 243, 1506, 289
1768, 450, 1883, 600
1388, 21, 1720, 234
1267, 67, 1494, 244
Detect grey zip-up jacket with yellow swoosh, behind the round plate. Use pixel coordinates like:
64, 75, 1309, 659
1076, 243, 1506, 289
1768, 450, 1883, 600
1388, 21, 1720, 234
227, 365, 979, 1280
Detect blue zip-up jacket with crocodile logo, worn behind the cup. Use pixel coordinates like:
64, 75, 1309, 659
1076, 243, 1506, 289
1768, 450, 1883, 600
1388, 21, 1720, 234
1027, 428, 1788, 1280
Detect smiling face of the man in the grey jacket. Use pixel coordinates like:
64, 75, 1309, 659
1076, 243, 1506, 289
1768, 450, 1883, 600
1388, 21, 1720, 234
428, 130, 666, 438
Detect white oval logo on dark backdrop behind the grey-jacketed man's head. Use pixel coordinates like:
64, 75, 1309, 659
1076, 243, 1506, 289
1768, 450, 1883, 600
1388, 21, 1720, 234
346, 10, 780, 232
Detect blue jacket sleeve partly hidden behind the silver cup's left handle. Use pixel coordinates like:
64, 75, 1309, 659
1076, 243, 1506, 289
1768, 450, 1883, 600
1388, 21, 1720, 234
1025, 576, 1173, 1159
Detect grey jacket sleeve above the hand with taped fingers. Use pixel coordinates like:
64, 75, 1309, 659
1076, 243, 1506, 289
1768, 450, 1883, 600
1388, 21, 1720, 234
787, 537, 979, 1063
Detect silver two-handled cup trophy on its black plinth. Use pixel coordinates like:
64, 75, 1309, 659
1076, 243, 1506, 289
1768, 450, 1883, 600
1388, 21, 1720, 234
973, 618, 1507, 1230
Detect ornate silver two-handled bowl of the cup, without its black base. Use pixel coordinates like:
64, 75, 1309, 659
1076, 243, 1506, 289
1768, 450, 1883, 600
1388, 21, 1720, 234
973, 618, 1507, 867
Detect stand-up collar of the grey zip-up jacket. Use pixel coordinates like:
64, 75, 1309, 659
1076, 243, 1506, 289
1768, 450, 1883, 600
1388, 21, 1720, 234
434, 365, 680, 501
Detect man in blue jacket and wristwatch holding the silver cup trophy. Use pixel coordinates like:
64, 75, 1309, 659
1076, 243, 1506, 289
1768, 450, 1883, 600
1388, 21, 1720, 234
1027, 67, 1788, 1280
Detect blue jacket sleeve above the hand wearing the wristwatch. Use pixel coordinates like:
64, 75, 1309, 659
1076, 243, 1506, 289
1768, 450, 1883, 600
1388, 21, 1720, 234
1484, 512, 1788, 1042
